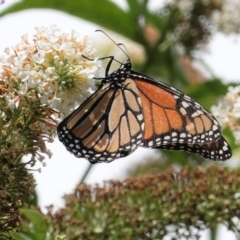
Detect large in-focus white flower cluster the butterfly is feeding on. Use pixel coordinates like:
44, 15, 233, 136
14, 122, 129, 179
0, 26, 103, 115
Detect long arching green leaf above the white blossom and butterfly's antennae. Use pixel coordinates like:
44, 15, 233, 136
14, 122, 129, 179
0, 0, 135, 38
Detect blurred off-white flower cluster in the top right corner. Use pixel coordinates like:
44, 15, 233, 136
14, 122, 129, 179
212, 0, 240, 34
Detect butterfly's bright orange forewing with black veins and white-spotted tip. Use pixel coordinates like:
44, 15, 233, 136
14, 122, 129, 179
133, 74, 221, 147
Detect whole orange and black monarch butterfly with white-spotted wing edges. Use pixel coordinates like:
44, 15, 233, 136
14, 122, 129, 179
57, 54, 232, 163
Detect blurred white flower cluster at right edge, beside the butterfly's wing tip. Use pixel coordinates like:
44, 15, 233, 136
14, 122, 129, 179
212, 86, 240, 144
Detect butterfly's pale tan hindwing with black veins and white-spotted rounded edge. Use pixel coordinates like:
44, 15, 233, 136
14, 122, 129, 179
58, 79, 144, 163
